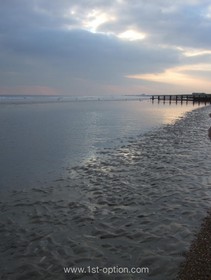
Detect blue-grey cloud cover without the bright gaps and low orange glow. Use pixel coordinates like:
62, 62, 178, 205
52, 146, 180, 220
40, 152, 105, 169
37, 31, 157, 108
0, 0, 211, 93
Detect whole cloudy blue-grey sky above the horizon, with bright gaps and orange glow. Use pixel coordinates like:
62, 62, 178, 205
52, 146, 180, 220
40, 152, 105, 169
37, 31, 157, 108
0, 0, 211, 96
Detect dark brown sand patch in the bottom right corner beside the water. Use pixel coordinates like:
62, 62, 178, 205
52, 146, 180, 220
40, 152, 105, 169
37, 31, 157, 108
178, 212, 211, 280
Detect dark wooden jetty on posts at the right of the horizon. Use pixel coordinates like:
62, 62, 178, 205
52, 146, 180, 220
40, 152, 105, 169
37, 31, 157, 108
151, 93, 211, 104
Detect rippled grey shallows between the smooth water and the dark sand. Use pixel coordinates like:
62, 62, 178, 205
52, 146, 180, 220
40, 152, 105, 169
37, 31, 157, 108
0, 101, 211, 280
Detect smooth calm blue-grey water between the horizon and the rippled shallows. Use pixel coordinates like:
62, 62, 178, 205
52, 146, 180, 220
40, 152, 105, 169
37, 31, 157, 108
0, 98, 201, 190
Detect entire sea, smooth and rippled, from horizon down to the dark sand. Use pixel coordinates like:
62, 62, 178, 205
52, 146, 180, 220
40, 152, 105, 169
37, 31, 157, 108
0, 96, 211, 280
